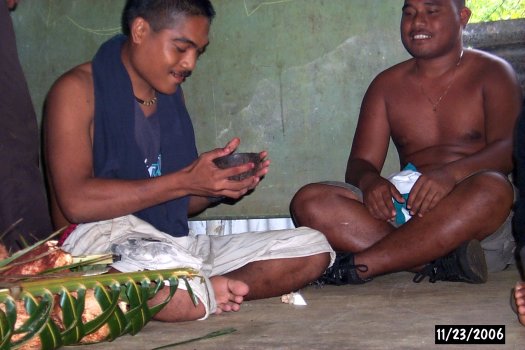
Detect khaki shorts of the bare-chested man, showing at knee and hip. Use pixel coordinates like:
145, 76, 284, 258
321, 181, 516, 272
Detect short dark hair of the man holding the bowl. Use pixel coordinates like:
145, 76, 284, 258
122, 0, 215, 35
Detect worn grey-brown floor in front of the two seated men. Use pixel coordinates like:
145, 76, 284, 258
77, 266, 525, 350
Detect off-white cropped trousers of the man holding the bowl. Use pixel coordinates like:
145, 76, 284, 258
62, 215, 335, 318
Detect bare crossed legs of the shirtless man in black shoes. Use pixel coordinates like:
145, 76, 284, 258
291, 172, 514, 278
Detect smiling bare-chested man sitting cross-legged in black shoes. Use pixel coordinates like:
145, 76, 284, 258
291, 0, 521, 284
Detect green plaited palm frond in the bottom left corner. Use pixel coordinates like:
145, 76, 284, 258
0, 269, 199, 349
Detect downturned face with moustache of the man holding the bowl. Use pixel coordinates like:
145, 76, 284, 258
134, 16, 210, 94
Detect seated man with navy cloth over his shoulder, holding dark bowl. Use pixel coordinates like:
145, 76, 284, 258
45, 0, 335, 321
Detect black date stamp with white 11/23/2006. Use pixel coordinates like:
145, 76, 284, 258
434, 325, 505, 344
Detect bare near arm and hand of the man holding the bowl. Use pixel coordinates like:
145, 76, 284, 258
45, 64, 267, 227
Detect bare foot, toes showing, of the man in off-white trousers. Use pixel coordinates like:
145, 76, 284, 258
210, 276, 250, 314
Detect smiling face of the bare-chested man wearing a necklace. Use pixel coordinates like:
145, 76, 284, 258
400, 0, 470, 58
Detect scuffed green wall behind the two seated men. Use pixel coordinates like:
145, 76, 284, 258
12, 0, 408, 218
